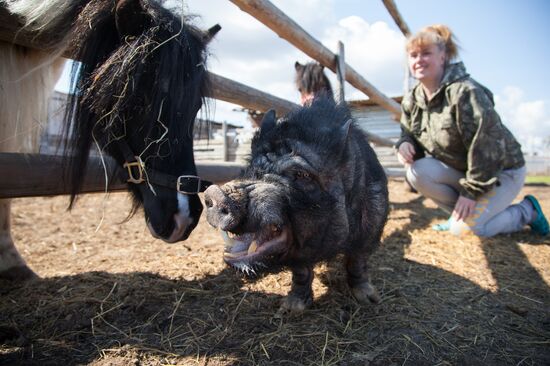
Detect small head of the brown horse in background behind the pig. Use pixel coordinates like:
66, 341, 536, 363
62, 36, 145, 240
295, 62, 334, 99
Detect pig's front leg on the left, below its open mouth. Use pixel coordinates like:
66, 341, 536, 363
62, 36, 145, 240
279, 266, 313, 314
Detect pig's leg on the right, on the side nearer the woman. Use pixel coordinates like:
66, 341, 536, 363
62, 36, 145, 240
345, 253, 380, 305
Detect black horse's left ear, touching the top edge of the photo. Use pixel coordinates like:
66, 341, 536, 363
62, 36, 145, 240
115, 0, 149, 38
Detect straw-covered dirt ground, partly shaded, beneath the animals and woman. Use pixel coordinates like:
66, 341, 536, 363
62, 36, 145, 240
0, 181, 550, 366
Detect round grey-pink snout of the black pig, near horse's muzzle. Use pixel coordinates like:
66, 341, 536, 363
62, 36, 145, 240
204, 185, 242, 231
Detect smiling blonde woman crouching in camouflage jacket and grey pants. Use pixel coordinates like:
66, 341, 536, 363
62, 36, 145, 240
396, 25, 550, 237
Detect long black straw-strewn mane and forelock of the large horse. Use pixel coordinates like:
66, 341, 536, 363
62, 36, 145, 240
57, 0, 209, 206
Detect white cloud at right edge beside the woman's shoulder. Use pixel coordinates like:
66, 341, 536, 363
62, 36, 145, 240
495, 86, 550, 151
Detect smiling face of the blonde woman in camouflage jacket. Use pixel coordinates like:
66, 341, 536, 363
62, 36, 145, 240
409, 44, 445, 84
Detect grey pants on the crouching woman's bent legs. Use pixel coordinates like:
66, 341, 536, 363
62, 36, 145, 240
406, 157, 535, 237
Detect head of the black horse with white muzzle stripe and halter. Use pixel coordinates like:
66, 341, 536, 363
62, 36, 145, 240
66, 0, 219, 243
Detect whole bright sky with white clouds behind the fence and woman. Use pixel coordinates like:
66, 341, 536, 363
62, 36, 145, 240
55, 0, 550, 145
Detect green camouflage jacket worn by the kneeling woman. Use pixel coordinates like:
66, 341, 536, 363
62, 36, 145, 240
396, 62, 525, 199
